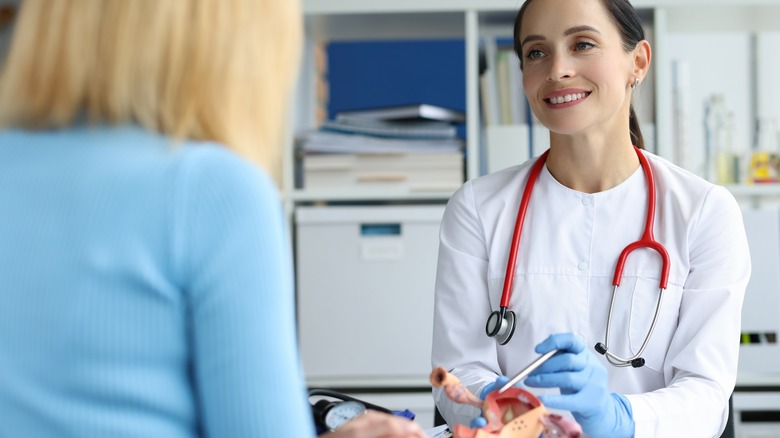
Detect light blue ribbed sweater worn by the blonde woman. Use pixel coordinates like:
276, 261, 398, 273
0, 127, 314, 438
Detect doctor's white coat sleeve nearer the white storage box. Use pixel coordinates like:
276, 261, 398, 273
432, 182, 499, 425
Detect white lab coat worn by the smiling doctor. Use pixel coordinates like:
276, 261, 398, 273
432, 152, 750, 437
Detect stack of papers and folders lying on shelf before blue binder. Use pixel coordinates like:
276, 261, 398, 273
299, 105, 464, 192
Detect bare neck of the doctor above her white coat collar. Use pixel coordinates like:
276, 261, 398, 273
546, 132, 639, 193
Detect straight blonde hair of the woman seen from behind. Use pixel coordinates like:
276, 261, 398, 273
0, 0, 302, 181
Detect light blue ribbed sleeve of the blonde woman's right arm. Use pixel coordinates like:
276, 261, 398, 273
173, 150, 314, 437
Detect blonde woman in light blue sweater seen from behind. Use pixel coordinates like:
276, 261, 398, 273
0, 0, 426, 437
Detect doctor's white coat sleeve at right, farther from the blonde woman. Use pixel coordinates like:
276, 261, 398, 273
627, 186, 750, 438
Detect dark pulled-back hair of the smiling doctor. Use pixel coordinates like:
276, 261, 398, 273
513, 0, 645, 149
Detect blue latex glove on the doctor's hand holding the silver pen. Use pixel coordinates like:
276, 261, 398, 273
525, 333, 634, 437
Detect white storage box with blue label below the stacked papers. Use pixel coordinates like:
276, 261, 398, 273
296, 205, 444, 387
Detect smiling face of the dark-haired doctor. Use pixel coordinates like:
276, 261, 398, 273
519, 0, 634, 136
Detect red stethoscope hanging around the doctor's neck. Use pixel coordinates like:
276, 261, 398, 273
485, 147, 669, 368
